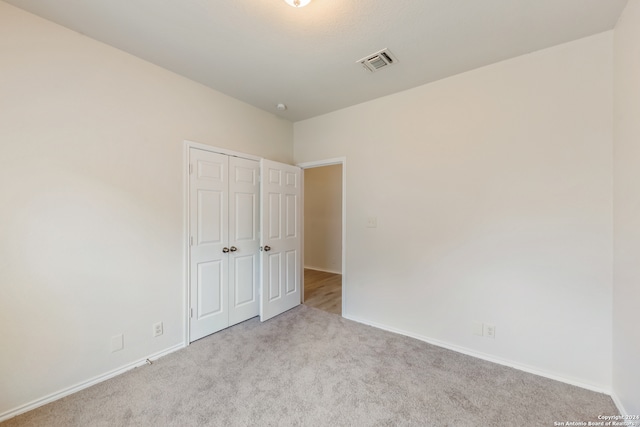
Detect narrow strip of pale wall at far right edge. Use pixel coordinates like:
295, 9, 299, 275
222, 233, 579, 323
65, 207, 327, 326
613, 0, 640, 414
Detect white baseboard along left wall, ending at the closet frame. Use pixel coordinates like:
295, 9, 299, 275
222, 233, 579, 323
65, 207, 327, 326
0, 343, 185, 422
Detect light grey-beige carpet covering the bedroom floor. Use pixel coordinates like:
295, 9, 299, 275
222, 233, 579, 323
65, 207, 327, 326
2, 305, 617, 427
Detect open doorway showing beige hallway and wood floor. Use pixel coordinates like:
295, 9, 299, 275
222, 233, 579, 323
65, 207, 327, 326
299, 159, 345, 315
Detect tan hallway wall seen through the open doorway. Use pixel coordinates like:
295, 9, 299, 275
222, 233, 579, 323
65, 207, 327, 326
304, 165, 342, 273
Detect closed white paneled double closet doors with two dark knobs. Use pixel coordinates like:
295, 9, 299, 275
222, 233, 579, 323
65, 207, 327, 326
189, 148, 260, 341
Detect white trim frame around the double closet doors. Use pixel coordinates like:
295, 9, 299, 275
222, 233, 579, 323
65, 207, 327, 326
182, 140, 261, 347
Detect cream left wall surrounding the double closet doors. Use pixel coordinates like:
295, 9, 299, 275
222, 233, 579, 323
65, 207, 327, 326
0, 2, 293, 418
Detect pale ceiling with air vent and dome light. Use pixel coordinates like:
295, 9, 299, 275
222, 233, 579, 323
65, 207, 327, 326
5, 0, 627, 121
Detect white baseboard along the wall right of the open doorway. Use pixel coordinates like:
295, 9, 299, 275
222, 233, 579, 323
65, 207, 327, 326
342, 314, 621, 398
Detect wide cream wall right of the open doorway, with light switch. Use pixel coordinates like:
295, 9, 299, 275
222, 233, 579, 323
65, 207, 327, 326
294, 32, 613, 391
